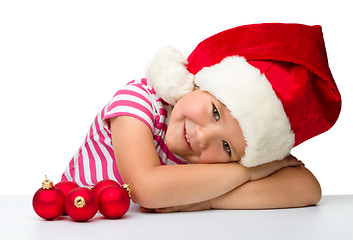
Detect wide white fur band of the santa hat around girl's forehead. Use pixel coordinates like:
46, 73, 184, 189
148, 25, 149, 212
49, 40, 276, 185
195, 56, 294, 167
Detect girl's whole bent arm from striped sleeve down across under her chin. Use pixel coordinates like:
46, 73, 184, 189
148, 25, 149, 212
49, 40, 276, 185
110, 116, 300, 208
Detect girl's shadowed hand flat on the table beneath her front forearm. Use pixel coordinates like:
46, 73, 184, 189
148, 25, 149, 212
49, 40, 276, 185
140, 201, 212, 213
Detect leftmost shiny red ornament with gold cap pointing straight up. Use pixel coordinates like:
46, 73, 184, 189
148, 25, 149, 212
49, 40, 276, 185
32, 179, 65, 220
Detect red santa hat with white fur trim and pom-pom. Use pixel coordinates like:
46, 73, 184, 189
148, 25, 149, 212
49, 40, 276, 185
146, 23, 341, 167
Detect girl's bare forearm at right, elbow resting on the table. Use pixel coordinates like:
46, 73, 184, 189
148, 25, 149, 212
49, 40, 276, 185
210, 166, 321, 209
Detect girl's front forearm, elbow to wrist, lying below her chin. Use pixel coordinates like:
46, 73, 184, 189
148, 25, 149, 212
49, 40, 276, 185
132, 163, 250, 208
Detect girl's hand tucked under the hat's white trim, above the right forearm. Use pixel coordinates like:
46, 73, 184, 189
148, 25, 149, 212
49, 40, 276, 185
249, 155, 304, 181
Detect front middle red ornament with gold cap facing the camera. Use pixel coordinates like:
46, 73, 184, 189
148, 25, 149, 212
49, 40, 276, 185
65, 187, 98, 222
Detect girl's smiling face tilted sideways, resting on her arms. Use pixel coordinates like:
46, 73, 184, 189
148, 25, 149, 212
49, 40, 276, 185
166, 90, 246, 163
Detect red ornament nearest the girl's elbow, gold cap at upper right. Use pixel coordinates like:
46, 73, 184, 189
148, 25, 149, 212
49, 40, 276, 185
98, 184, 130, 218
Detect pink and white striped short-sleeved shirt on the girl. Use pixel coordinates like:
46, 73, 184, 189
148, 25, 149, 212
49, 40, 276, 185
61, 78, 186, 186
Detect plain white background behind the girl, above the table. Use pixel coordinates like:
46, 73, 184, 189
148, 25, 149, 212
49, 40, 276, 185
0, 0, 353, 194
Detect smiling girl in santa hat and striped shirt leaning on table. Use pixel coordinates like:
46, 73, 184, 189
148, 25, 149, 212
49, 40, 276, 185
62, 23, 341, 212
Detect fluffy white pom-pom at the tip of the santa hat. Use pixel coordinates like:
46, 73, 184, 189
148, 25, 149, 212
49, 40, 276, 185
146, 47, 194, 105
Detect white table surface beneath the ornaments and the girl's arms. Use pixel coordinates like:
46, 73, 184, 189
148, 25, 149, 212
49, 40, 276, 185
0, 195, 353, 240
